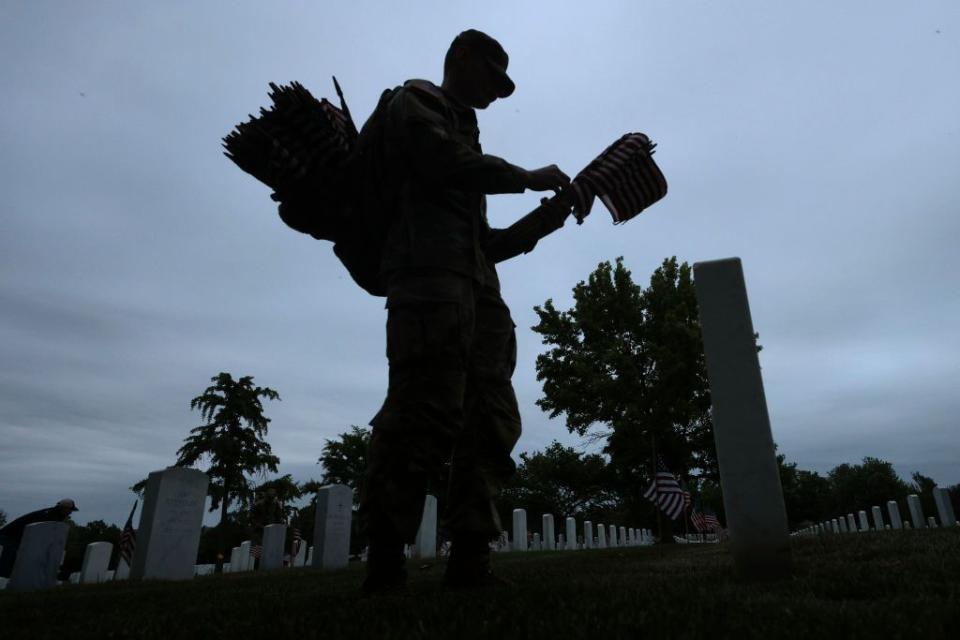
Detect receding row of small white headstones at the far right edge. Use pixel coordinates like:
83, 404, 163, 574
793, 487, 960, 535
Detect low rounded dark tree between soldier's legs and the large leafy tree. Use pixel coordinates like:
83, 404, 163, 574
498, 442, 619, 522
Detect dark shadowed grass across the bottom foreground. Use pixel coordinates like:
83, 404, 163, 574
0, 528, 960, 640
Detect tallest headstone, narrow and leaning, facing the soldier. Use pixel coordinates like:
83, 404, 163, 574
693, 258, 792, 578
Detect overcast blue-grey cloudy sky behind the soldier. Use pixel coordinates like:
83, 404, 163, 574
0, 0, 960, 523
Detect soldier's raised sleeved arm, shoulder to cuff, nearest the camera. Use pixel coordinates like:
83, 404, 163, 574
390, 89, 531, 194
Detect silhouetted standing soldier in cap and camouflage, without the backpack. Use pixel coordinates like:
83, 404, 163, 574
360, 30, 570, 592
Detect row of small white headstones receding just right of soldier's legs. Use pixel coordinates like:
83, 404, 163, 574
497, 509, 654, 551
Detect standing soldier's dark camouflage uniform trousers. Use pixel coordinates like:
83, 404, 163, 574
360, 270, 520, 542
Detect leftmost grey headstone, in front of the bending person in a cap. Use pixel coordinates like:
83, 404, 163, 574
7, 522, 70, 591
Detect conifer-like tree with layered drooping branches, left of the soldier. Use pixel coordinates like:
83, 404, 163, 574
176, 373, 280, 523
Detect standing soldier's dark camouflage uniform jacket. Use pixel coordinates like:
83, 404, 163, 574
378, 80, 526, 287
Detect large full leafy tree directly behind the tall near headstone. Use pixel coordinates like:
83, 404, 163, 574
533, 257, 717, 512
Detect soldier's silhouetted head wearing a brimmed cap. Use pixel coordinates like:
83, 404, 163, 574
443, 29, 516, 109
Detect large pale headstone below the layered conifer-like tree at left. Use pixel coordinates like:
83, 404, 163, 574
130, 467, 210, 580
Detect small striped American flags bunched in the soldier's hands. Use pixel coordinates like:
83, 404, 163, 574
570, 133, 667, 224
